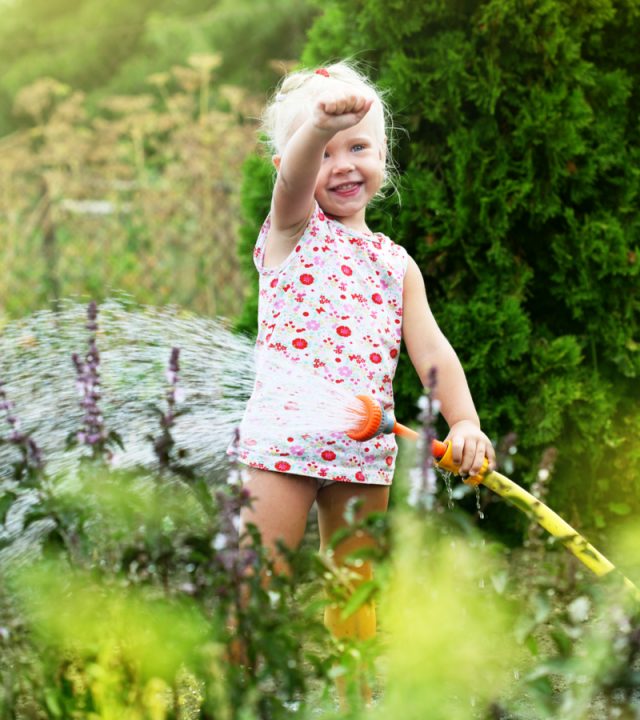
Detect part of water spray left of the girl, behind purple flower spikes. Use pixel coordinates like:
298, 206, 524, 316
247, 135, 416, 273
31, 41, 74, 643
0, 300, 255, 477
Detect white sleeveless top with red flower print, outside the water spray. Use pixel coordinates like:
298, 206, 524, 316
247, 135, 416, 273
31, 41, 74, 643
230, 203, 407, 485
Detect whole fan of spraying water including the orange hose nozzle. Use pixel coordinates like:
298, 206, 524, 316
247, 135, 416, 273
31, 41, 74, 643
0, 300, 415, 484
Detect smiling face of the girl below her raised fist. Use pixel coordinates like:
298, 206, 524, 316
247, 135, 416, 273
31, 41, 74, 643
315, 113, 386, 229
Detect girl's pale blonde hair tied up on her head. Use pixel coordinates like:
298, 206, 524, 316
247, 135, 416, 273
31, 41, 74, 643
260, 60, 396, 197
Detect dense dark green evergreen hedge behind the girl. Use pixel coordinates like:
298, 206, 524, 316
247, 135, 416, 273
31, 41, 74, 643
236, 0, 640, 527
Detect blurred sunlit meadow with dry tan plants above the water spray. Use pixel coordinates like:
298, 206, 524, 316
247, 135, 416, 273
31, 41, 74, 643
0, 0, 317, 318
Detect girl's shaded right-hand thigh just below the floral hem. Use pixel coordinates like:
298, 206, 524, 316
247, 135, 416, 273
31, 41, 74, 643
317, 482, 389, 572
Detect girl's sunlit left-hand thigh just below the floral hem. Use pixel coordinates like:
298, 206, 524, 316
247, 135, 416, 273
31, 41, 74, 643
241, 468, 318, 550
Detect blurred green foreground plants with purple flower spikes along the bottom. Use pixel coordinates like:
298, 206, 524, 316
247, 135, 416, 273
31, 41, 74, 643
0, 306, 640, 720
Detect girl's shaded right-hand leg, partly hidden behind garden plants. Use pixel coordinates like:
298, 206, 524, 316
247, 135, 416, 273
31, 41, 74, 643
317, 483, 389, 710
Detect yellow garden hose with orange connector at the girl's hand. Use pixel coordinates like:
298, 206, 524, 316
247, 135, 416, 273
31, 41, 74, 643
431, 440, 640, 602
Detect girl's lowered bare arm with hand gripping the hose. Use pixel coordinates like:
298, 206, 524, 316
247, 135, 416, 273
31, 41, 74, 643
402, 258, 496, 475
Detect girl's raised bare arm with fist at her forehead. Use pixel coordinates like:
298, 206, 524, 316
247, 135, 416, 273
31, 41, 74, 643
264, 87, 373, 267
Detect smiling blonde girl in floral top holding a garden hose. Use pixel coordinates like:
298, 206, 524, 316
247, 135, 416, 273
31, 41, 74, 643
232, 62, 495, 705
